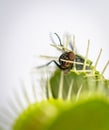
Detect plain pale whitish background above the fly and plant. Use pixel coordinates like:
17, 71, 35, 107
0, 0, 109, 103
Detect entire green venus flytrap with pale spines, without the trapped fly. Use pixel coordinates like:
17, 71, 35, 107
0, 34, 109, 130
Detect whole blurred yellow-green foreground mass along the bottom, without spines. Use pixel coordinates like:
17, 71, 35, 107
13, 95, 109, 130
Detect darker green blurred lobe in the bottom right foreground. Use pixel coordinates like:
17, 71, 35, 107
47, 98, 109, 130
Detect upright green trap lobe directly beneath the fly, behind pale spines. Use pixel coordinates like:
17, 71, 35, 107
47, 69, 109, 99
